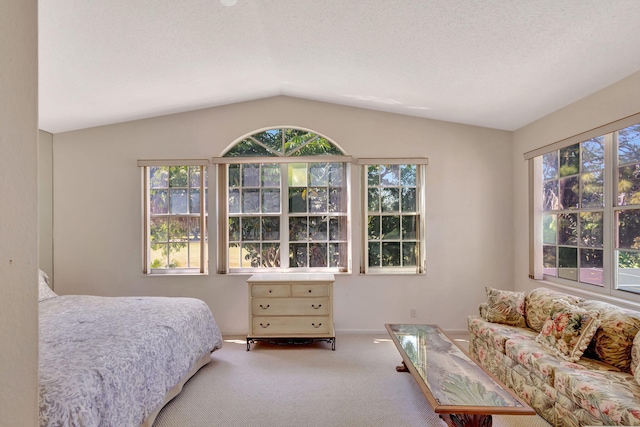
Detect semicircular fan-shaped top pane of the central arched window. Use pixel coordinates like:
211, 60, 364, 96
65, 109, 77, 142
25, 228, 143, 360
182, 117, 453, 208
223, 128, 344, 157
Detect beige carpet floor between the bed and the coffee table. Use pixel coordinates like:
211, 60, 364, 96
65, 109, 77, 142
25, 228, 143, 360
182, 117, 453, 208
154, 334, 549, 427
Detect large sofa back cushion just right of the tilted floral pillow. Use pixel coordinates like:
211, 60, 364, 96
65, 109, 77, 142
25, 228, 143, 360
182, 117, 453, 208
578, 300, 640, 373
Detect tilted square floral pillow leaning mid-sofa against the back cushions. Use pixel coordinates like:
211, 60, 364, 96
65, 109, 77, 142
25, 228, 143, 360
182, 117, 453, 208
536, 302, 600, 362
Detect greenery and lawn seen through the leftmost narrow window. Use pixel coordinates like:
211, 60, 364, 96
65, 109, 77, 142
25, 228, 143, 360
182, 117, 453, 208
144, 162, 207, 274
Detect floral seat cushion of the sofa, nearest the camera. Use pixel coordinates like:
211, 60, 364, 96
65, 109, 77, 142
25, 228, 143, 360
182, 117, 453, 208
554, 367, 640, 425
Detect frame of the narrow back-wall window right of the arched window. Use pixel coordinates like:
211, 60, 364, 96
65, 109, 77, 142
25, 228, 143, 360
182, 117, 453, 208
357, 158, 429, 274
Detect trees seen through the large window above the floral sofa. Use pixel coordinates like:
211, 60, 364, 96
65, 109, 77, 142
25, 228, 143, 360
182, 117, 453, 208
538, 125, 640, 294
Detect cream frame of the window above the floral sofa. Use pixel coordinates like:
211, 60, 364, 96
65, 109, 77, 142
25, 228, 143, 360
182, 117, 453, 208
524, 114, 640, 305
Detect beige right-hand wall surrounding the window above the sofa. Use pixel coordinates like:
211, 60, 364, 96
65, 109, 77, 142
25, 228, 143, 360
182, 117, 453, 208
513, 72, 640, 302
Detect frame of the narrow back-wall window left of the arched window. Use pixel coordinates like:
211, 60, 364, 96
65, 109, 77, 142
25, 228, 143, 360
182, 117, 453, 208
138, 159, 209, 276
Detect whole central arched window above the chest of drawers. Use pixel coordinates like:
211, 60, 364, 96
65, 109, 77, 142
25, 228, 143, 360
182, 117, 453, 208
213, 128, 351, 273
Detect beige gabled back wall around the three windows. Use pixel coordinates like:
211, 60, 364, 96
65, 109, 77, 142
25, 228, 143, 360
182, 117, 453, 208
53, 97, 514, 334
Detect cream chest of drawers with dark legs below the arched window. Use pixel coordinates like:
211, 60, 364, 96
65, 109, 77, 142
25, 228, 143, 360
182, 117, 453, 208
247, 273, 335, 350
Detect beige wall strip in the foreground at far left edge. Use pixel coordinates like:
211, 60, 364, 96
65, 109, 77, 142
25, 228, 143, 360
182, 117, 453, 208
0, 0, 38, 426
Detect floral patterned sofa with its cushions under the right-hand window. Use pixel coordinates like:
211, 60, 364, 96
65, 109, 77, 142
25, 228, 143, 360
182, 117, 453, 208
468, 288, 640, 426
